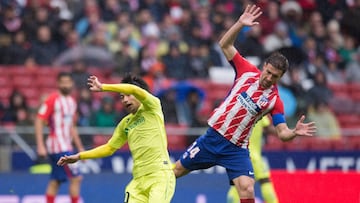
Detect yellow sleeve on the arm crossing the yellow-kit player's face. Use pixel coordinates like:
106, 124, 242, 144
102, 83, 150, 103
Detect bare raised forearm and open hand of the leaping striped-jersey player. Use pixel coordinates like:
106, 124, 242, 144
219, 5, 262, 61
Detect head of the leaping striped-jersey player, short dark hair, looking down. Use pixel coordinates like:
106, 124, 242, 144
260, 52, 289, 88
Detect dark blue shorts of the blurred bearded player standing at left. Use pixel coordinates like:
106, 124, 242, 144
49, 152, 80, 182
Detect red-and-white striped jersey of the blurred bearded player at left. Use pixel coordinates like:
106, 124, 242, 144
38, 93, 76, 154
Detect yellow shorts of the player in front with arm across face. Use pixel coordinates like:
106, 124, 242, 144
124, 170, 176, 203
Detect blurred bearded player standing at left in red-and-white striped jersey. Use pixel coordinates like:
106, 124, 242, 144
35, 72, 84, 203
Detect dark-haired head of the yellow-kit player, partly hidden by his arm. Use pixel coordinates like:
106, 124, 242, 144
120, 74, 149, 113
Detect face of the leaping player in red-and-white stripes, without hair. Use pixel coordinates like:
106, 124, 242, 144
260, 63, 283, 89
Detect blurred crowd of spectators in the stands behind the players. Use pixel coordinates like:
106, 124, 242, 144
0, 0, 360, 146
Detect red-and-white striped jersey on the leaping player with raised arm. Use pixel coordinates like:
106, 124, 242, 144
208, 53, 284, 148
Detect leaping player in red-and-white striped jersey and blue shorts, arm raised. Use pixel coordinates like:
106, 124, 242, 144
174, 5, 316, 203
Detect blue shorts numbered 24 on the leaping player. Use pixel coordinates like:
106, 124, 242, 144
180, 128, 254, 180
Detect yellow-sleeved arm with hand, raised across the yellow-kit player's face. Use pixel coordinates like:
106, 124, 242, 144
88, 76, 148, 101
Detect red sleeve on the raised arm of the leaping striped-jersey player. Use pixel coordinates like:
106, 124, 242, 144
229, 52, 260, 78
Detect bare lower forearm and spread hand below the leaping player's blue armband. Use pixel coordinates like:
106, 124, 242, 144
276, 115, 316, 141
